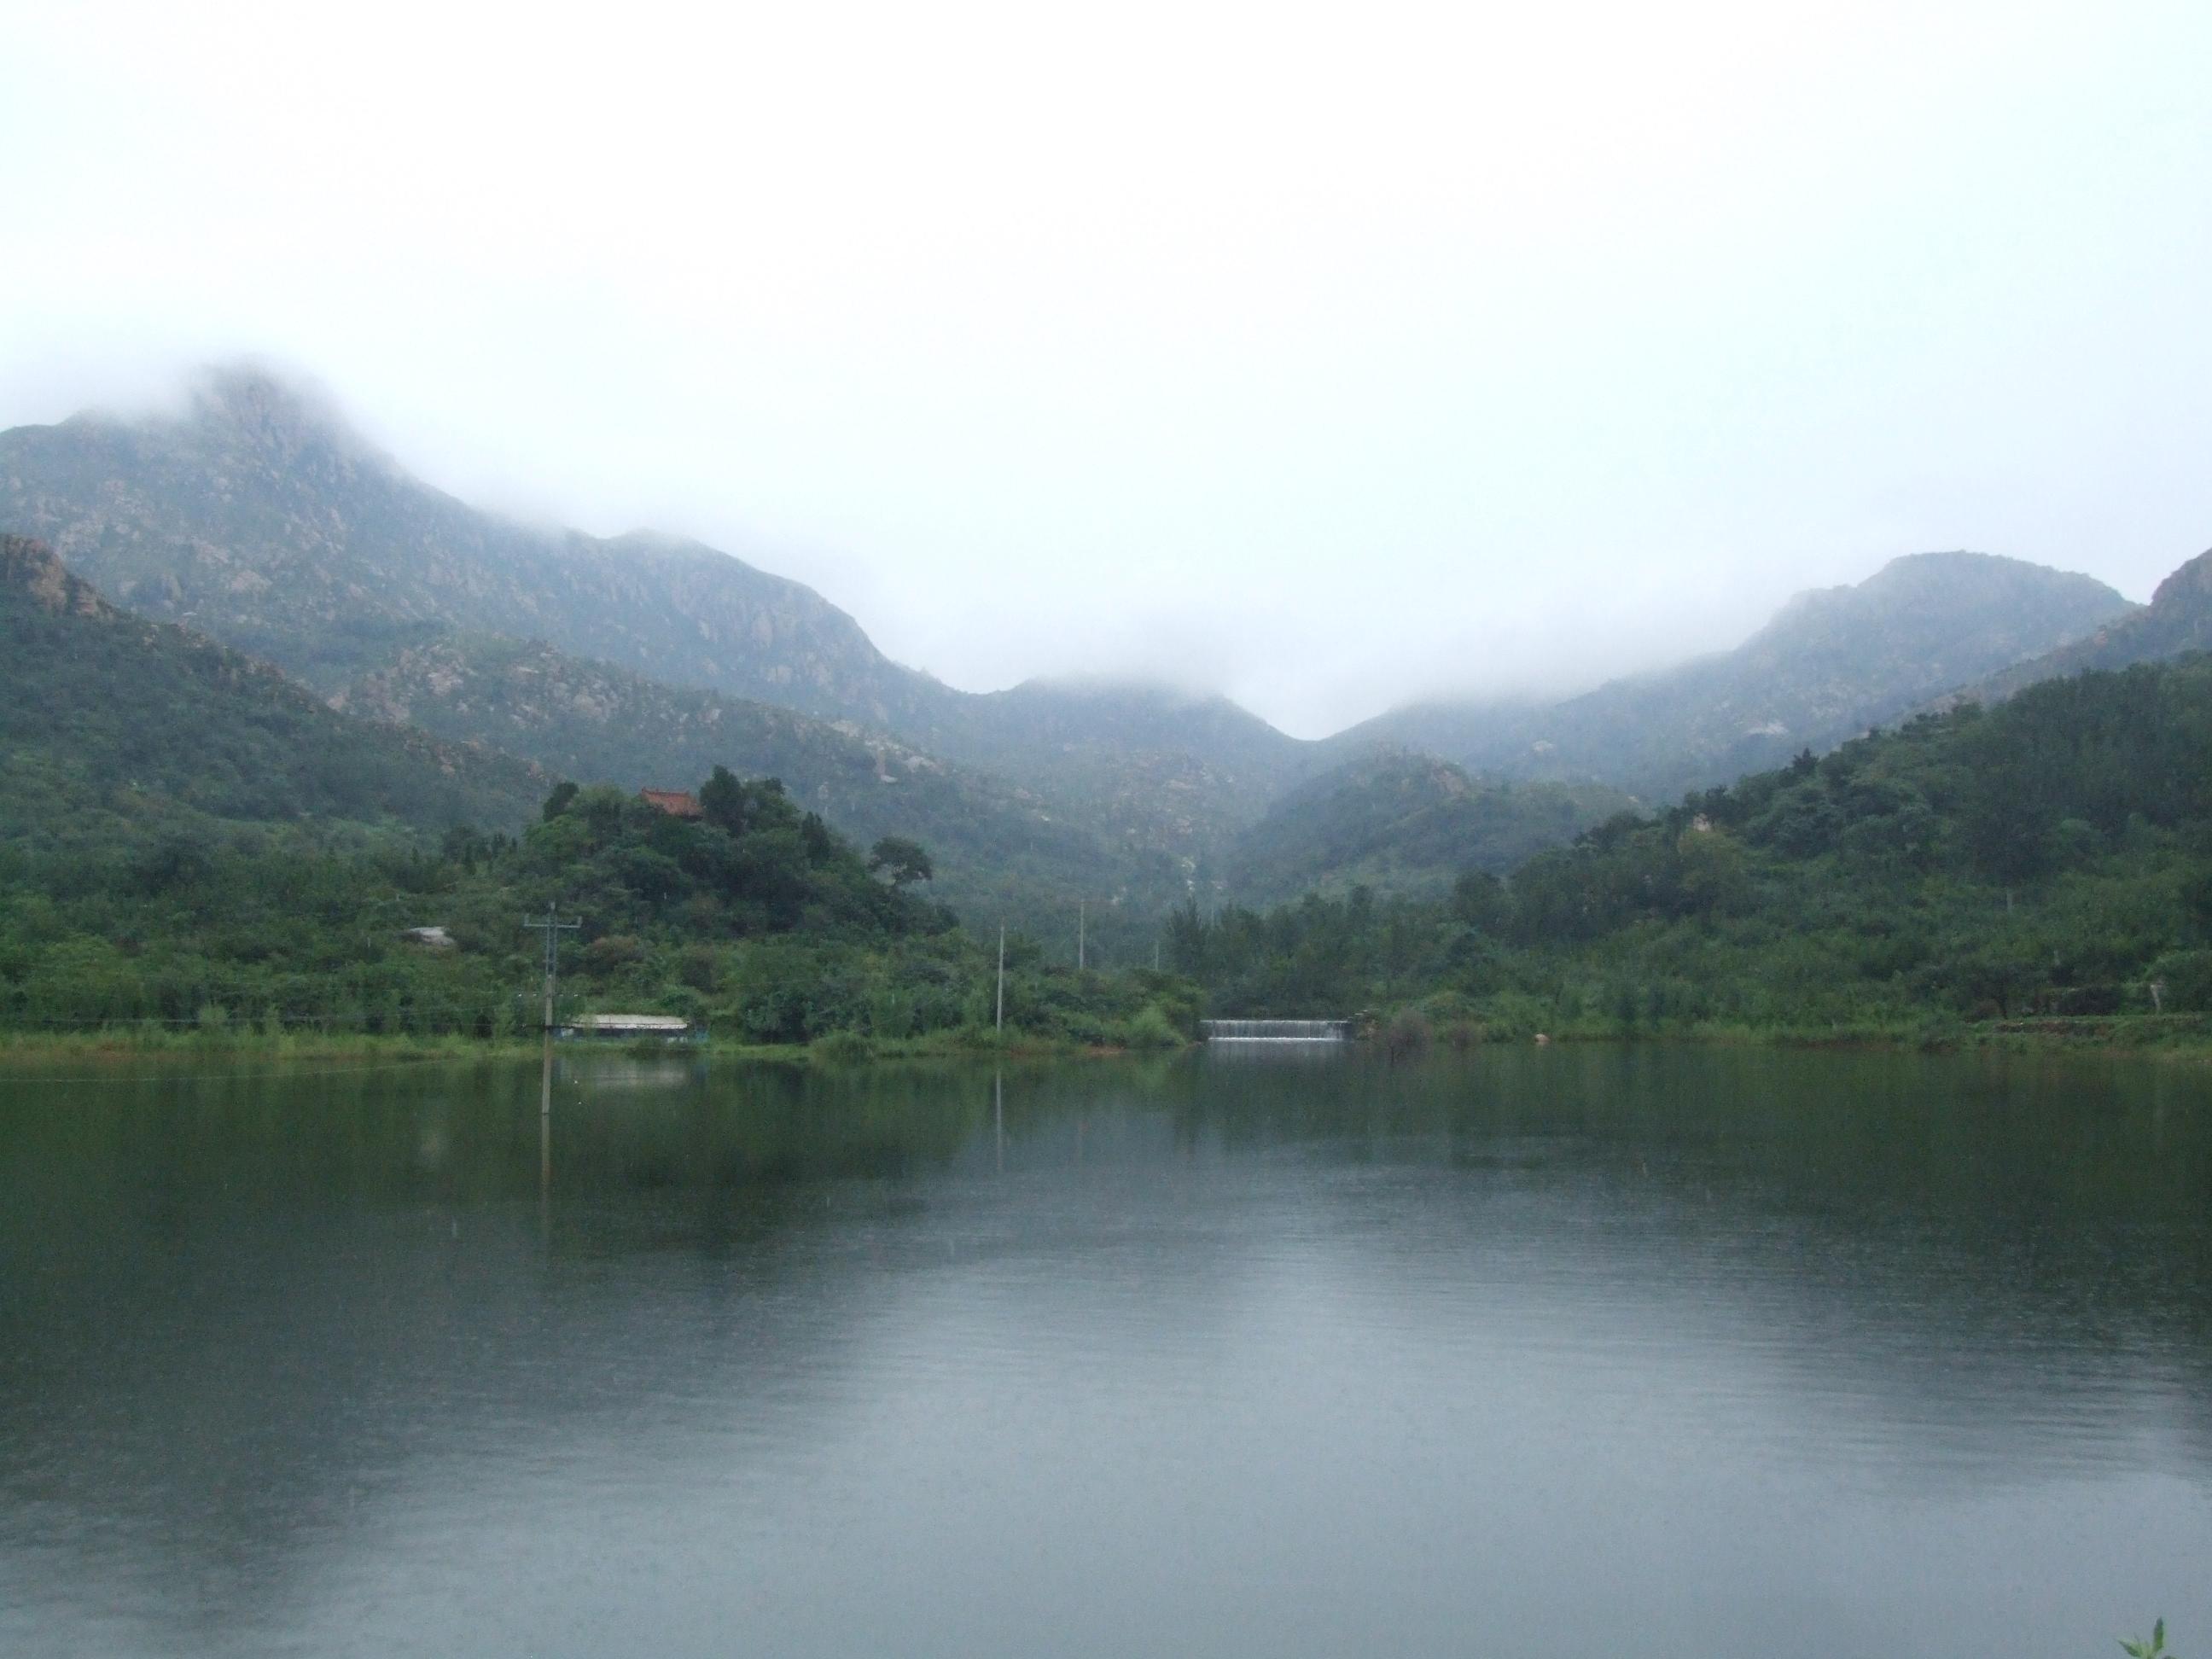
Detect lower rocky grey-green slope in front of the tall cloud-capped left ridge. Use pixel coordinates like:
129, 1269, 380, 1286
334, 637, 1181, 920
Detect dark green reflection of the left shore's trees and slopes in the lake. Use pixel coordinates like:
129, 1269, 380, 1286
0, 1068, 989, 1645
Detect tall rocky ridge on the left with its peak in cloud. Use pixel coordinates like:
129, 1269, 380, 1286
0, 371, 949, 725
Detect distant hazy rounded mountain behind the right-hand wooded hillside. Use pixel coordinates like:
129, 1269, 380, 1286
1334, 553, 2130, 799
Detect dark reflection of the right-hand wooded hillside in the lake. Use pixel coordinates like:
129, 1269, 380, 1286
1212, 1046, 2212, 1484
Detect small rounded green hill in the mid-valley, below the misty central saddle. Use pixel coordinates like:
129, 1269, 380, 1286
1221, 750, 1634, 905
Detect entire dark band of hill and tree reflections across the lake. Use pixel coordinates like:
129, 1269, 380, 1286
0, 1049, 2212, 1619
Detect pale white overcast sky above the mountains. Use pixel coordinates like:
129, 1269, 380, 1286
0, 0, 2212, 735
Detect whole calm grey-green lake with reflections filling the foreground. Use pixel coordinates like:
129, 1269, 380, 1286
0, 1046, 2212, 1659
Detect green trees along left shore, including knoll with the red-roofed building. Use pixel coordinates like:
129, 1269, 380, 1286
0, 770, 1196, 1042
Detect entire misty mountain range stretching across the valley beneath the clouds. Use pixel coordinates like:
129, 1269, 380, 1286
0, 371, 2212, 938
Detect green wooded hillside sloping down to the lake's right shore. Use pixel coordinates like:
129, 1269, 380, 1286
1168, 657, 2212, 1031
